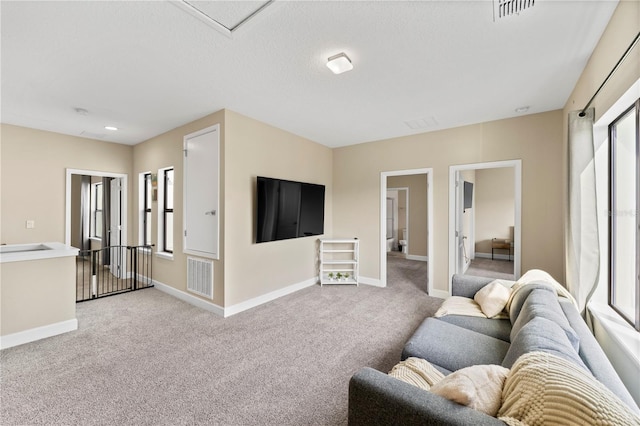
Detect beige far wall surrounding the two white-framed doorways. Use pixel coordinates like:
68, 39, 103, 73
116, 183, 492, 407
333, 111, 563, 291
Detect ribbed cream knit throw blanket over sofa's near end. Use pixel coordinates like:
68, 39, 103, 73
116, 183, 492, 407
497, 352, 640, 426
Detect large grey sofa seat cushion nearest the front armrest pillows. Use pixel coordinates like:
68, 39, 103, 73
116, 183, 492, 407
402, 317, 509, 371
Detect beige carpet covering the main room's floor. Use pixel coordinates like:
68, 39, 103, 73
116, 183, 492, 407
0, 267, 442, 425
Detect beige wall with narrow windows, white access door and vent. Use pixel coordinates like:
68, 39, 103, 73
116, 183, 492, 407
132, 111, 225, 306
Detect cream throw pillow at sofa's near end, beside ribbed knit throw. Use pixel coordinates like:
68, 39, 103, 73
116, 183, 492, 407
431, 365, 509, 417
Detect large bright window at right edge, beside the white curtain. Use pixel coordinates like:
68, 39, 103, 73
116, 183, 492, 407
609, 99, 640, 330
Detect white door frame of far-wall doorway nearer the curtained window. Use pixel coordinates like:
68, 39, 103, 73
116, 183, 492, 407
448, 160, 522, 294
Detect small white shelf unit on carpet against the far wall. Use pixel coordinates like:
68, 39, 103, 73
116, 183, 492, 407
318, 238, 360, 286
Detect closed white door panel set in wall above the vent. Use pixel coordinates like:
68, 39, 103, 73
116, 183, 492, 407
184, 125, 220, 259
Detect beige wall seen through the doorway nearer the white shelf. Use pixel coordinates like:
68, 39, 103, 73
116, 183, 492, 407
387, 174, 428, 256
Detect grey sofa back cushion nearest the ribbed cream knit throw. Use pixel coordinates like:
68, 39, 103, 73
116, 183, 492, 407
502, 317, 589, 371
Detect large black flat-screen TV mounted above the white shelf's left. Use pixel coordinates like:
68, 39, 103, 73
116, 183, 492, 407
256, 176, 325, 243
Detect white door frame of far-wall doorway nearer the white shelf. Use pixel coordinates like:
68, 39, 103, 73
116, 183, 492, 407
378, 167, 434, 295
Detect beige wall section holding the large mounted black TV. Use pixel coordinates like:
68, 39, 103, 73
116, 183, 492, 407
224, 110, 336, 306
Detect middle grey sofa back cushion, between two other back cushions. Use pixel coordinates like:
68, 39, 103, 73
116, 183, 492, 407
510, 288, 580, 352
